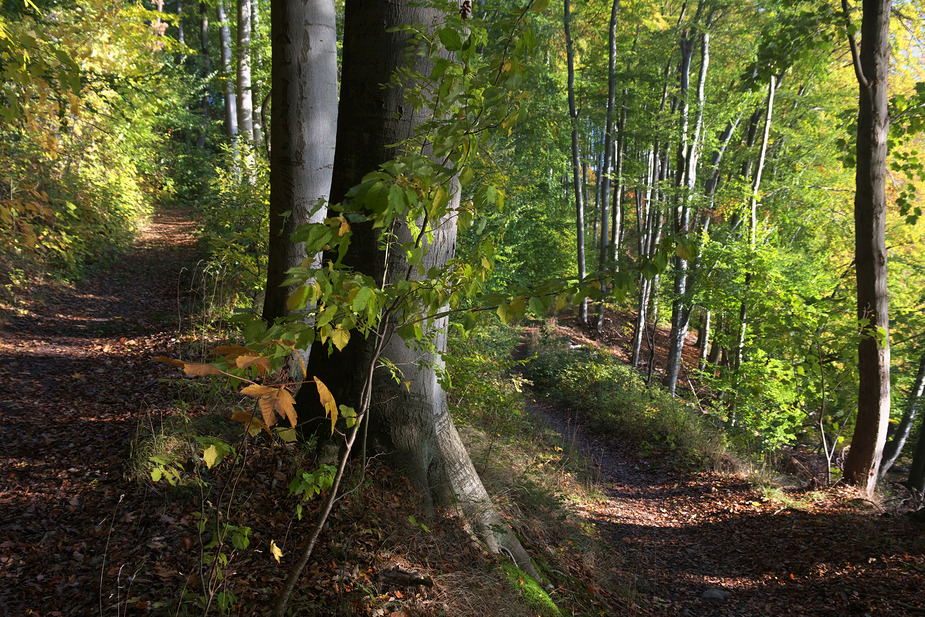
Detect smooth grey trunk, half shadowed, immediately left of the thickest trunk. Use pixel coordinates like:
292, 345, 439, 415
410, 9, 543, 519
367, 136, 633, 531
263, 0, 337, 322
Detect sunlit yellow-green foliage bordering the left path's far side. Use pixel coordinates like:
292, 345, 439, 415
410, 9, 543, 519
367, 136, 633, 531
0, 2, 186, 292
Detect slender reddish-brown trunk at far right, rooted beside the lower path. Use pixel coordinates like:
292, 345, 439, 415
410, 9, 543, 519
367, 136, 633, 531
842, 0, 891, 495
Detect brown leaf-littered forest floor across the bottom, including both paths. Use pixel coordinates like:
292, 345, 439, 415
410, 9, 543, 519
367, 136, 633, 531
0, 205, 925, 617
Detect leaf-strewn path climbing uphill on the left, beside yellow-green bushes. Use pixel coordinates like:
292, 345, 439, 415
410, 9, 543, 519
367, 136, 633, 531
0, 206, 195, 616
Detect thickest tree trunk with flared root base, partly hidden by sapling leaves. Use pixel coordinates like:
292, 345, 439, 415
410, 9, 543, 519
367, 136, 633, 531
292, 0, 535, 572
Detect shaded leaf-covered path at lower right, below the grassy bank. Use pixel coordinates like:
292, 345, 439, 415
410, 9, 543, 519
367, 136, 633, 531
530, 390, 925, 616
